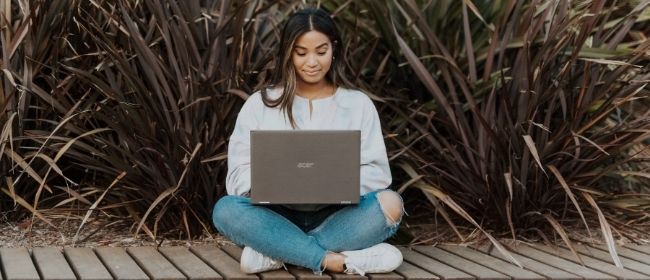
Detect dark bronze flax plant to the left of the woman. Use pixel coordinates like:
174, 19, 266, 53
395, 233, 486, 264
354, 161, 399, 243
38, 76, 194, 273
1, 0, 296, 239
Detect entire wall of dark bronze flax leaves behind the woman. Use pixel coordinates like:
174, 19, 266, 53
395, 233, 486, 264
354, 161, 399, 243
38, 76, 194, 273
0, 0, 650, 256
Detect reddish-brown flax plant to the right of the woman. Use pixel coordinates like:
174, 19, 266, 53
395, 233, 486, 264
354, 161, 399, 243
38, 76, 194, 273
344, 0, 650, 265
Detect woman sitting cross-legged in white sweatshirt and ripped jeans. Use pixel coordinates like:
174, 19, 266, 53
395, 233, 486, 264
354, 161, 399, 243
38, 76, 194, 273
213, 9, 404, 275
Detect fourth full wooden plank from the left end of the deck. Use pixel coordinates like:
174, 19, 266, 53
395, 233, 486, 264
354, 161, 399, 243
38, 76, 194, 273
95, 247, 149, 280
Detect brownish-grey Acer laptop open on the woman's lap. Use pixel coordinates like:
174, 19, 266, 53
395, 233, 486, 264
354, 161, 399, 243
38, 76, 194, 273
251, 130, 361, 204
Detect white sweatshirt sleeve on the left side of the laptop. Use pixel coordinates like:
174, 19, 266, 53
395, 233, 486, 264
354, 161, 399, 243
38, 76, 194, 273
226, 96, 258, 196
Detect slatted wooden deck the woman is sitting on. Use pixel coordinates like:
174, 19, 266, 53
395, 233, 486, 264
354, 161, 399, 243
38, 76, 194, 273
0, 245, 650, 280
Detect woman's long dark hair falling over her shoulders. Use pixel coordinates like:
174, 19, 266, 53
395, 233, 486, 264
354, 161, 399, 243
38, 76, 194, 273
261, 8, 352, 129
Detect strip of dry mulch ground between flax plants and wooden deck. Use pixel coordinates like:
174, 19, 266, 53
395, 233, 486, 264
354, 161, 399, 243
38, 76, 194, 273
0, 210, 650, 248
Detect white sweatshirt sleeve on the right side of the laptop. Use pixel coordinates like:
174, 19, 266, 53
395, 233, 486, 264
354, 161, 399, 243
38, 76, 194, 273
361, 98, 392, 195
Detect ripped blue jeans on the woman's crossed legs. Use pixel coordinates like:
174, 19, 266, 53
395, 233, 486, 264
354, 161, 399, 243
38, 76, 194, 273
212, 190, 401, 272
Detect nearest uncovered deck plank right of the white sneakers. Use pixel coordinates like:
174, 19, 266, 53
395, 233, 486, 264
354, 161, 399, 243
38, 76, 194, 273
399, 247, 468, 280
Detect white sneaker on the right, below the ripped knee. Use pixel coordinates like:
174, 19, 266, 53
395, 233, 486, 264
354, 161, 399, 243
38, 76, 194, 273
341, 243, 402, 276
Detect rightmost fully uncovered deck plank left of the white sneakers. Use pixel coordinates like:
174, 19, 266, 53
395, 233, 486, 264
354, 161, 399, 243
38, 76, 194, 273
190, 246, 258, 280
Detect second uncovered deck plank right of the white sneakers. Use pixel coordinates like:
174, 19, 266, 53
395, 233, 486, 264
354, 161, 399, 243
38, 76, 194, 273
415, 246, 510, 280
